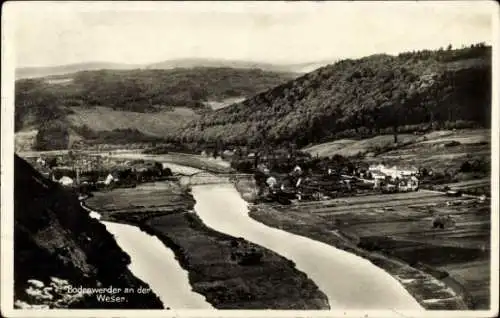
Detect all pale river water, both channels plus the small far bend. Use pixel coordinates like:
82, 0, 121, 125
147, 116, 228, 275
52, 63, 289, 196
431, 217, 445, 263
87, 156, 423, 310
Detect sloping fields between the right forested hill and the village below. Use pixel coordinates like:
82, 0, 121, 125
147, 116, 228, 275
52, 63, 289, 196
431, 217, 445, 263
303, 129, 491, 171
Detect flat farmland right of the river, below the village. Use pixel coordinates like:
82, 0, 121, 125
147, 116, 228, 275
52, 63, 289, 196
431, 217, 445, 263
250, 190, 490, 309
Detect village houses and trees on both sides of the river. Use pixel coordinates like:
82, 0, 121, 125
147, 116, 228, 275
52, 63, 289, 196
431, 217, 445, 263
27, 148, 472, 204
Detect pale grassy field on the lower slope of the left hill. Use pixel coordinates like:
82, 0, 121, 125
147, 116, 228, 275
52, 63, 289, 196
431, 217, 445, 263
68, 107, 198, 137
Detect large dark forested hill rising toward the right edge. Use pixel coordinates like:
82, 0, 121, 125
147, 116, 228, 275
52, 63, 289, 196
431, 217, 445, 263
178, 43, 491, 146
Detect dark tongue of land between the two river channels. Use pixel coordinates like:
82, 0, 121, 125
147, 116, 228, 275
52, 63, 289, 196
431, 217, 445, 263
85, 182, 330, 309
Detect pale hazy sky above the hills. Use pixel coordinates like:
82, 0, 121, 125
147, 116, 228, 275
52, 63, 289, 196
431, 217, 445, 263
3, 1, 497, 67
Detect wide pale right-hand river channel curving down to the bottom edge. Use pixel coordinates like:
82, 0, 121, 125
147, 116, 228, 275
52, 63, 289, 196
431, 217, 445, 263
192, 184, 423, 310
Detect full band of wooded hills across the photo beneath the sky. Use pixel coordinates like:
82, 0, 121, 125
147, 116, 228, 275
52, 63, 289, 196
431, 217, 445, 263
16, 44, 491, 152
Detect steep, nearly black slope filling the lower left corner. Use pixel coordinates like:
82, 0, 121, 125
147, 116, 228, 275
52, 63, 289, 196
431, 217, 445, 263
14, 155, 163, 309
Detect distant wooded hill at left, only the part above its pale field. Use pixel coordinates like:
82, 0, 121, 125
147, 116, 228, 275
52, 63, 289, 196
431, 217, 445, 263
15, 67, 296, 131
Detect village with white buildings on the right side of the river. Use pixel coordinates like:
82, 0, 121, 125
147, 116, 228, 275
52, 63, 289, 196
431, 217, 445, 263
222, 150, 422, 204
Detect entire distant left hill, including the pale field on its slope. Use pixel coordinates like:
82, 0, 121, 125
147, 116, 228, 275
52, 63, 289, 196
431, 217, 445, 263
15, 67, 297, 150
